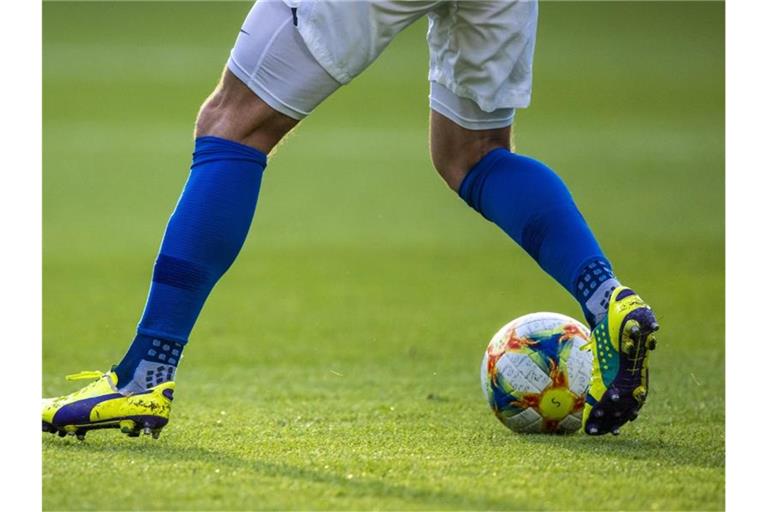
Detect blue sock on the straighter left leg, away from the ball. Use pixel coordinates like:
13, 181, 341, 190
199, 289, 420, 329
115, 137, 267, 391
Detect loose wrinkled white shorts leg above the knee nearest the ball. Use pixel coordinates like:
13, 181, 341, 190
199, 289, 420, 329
427, 0, 538, 112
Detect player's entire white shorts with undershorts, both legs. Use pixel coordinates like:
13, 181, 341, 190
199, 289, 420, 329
227, 0, 538, 130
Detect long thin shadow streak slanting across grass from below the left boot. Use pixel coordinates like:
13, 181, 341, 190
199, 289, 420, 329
44, 439, 524, 510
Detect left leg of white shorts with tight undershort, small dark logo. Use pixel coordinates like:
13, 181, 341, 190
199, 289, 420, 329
227, 0, 440, 120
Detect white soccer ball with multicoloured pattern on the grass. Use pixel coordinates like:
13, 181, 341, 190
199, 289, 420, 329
480, 313, 592, 433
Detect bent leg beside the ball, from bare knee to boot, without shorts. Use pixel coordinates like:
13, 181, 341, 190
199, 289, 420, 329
430, 104, 658, 434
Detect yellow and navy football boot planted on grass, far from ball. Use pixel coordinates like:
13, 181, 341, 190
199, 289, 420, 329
43, 371, 176, 440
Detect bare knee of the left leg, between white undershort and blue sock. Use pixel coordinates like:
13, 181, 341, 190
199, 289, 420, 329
195, 70, 298, 153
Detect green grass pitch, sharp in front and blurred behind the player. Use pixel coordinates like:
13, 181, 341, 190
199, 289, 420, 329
42, 2, 725, 510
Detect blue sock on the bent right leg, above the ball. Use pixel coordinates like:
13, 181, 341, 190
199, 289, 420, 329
459, 148, 618, 325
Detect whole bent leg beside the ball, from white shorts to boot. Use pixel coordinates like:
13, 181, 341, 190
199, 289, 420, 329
429, 2, 658, 434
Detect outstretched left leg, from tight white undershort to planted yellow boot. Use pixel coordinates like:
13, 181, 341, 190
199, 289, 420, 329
43, 2, 340, 437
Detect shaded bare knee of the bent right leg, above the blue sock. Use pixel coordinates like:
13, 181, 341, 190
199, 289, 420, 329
430, 111, 512, 191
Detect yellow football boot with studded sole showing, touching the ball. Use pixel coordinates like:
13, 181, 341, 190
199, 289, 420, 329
583, 286, 659, 435
